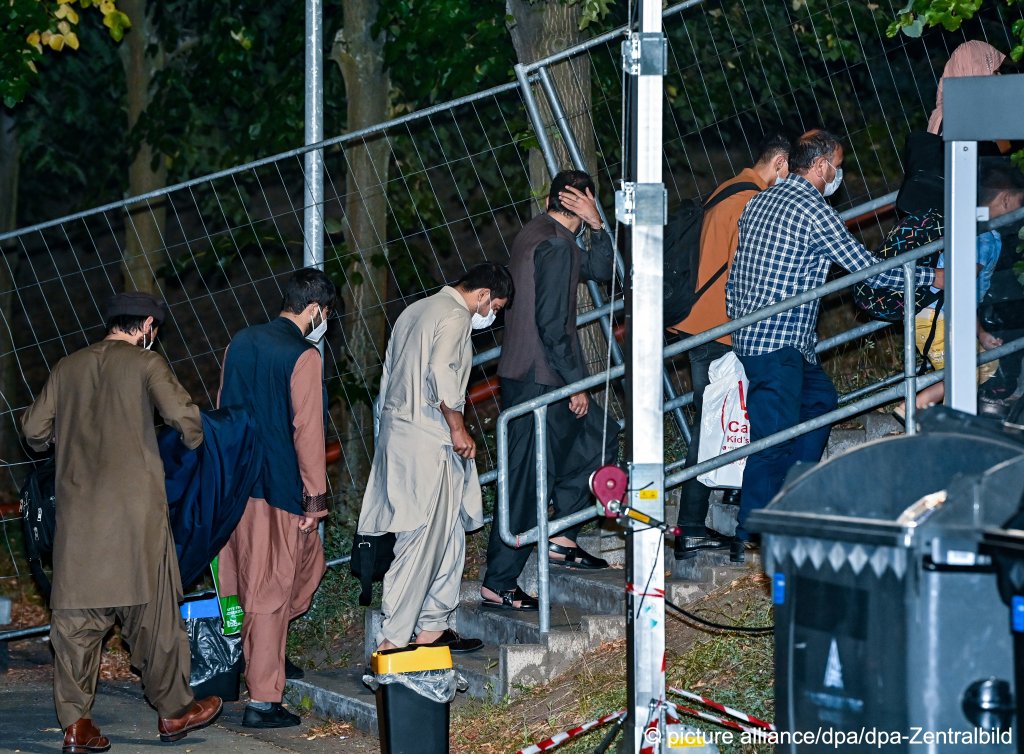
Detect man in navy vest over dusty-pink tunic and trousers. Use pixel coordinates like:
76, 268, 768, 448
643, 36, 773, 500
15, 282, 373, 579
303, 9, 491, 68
219, 268, 337, 727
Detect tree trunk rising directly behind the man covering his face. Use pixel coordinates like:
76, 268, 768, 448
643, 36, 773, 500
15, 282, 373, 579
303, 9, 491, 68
506, 0, 607, 383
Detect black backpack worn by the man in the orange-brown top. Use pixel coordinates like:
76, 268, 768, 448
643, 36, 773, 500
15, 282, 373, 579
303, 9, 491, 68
663, 181, 761, 327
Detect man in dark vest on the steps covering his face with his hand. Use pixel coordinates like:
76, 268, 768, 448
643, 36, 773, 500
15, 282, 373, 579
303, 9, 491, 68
480, 170, 617, 610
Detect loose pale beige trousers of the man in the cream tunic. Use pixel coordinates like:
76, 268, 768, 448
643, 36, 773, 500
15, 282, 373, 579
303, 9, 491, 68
376, 495, 466, 646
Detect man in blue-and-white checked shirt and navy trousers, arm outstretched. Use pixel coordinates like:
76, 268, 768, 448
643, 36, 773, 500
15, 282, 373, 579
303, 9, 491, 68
726, 130, 944, 561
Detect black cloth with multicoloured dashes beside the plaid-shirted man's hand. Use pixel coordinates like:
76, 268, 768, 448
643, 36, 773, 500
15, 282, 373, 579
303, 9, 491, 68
853, 209, 944, 322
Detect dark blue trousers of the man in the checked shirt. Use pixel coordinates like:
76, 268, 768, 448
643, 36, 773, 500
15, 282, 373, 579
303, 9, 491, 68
736, 347, 839, 540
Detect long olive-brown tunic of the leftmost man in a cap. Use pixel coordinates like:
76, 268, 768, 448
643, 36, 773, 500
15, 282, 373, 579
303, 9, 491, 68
22, 340, 203, 609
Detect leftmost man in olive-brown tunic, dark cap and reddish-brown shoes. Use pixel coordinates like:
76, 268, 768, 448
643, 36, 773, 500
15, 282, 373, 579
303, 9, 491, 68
22, 293, 221, 752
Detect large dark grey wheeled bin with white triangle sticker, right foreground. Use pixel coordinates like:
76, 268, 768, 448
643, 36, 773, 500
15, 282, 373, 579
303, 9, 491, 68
750, 417, 1024, 754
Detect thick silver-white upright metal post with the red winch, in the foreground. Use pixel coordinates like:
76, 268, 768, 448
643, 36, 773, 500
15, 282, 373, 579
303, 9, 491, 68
615, 0, 668, 754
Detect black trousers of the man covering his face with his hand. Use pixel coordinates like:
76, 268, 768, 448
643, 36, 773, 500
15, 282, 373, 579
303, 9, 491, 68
483, 378, 618, 592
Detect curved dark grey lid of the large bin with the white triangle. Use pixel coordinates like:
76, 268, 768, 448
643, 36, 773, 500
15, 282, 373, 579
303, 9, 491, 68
748, 432, 1024, 546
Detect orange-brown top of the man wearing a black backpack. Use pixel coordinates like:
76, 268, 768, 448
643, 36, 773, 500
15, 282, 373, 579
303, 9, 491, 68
670, 168, 768, 345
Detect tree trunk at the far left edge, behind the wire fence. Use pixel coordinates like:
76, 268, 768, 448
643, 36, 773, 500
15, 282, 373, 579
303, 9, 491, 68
0, 106, 22, 495
